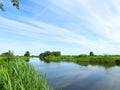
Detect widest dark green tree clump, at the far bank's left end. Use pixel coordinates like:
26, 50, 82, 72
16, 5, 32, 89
39, 51, 61, 59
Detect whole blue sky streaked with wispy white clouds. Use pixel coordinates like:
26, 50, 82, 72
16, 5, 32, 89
0, 0, 120, 55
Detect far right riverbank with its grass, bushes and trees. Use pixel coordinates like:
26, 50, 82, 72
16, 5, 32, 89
39, 51, 120, 64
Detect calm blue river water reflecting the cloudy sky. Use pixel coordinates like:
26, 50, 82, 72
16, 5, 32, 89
29, 58, 120, 90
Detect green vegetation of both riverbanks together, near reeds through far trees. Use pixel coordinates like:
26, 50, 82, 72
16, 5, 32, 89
0, 50, 120, 90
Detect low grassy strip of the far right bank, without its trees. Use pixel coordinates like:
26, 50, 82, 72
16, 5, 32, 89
41, 55, 120, 64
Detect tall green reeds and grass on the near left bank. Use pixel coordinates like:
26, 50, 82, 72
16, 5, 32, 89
0, 57, 50, 90
